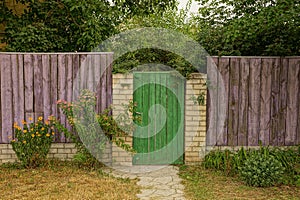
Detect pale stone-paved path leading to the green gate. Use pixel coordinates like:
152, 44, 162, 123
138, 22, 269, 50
103, 166, 185, 200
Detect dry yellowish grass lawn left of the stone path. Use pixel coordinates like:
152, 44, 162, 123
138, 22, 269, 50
0, 161, 139, 200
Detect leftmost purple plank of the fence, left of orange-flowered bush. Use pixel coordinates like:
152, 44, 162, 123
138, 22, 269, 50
0, 55, 13, 143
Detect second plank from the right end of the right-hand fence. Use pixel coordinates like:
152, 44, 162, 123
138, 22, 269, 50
270, 58, 281, 146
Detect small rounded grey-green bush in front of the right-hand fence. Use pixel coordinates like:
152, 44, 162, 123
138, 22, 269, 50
240, 153, 284, 187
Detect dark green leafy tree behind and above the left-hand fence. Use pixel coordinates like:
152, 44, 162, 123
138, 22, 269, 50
0, 0, 175, 52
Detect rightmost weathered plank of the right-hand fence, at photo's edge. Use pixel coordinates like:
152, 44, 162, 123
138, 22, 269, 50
285, 58, 300, 145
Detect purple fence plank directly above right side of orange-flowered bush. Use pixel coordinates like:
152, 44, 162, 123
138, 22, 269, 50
42, 55, 51, 118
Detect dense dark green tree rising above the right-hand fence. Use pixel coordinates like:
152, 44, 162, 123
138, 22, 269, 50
197, 0, 300, 56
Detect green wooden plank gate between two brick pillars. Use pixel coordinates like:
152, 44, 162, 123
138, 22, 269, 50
133, 72, 185, 165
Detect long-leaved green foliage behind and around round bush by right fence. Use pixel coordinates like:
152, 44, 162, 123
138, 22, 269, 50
203, 146, 300, 185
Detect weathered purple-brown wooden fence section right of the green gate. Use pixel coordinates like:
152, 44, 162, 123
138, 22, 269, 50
207, 57, 300, 146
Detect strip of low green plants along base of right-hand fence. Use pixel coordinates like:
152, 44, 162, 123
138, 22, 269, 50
203, 146, 300, 186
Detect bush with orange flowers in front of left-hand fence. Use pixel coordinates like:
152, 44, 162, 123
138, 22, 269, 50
11, 116, 56, 167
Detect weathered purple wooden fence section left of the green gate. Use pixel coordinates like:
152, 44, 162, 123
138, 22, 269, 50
0, 53, 113, 143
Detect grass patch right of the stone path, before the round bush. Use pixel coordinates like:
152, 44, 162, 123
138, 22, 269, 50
180, 166, 300, 200
